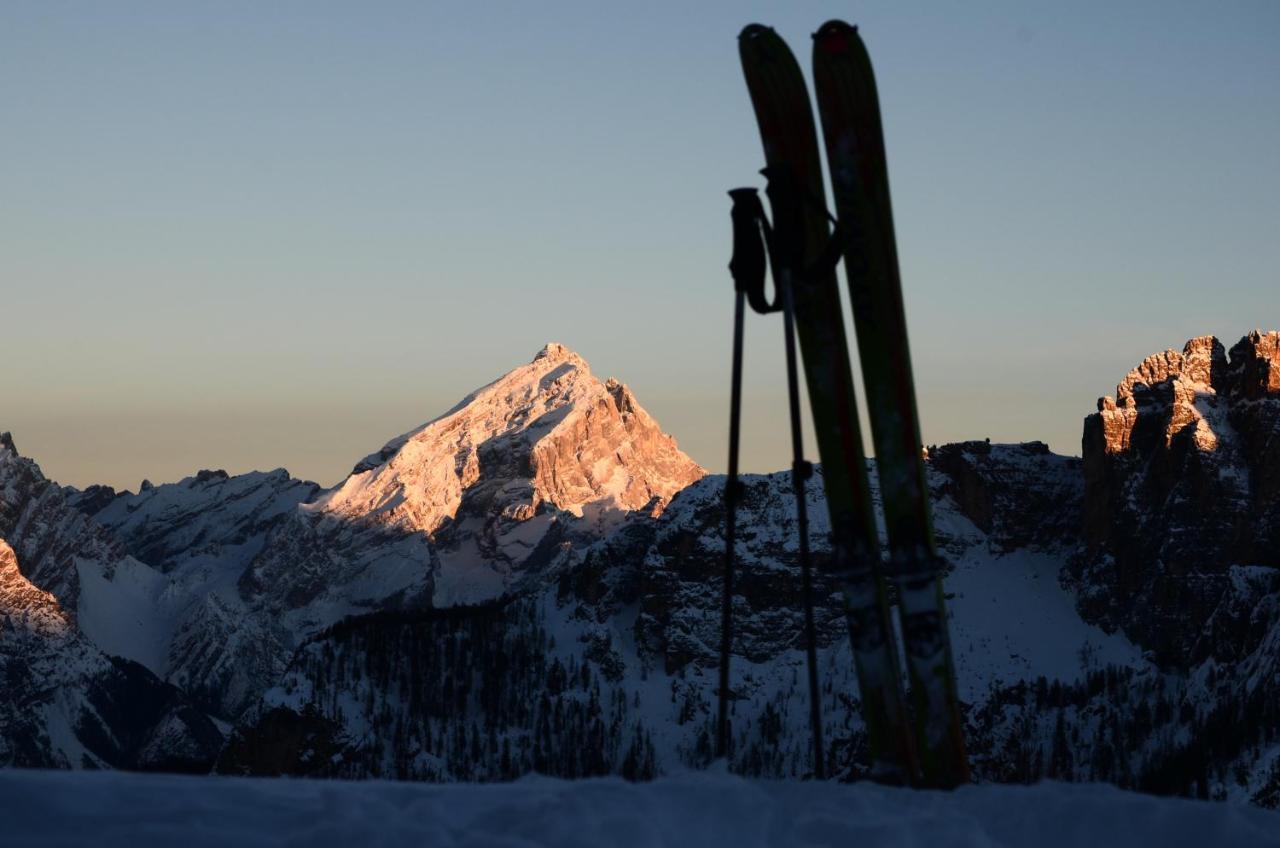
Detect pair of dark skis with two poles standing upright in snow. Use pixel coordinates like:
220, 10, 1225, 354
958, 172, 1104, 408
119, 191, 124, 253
719, 20, 969, 788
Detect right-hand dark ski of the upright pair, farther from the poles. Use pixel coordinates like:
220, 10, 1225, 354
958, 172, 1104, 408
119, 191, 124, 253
813, 20, 969, 788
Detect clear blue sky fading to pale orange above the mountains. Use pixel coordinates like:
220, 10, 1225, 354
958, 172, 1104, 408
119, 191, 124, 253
0, 0, 1280, 488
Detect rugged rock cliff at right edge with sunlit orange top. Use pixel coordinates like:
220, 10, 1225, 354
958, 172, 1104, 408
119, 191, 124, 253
1076, 332, 1280, 665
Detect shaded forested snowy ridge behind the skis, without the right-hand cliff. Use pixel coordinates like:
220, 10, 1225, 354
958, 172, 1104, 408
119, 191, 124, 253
219, 338, 1280, 806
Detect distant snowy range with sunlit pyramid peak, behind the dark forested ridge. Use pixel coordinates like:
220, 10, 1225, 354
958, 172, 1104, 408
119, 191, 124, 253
10, 345, 704, 720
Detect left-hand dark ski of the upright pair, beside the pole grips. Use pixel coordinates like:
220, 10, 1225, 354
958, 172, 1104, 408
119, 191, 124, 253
739, 24, 918, 784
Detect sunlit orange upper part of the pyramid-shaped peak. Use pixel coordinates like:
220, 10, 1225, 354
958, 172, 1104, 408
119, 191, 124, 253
308, 342, 705, 534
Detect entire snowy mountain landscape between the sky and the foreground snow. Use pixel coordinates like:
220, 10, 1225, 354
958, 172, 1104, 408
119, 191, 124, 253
0, 332, 1280, 807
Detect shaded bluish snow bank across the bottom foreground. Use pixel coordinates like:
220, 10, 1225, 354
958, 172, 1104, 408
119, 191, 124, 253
0, 769, 1280, 848
